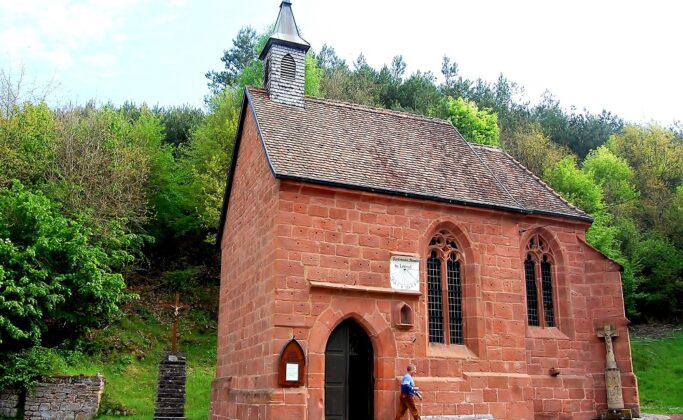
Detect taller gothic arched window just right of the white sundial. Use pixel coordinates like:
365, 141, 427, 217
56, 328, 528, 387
427, 231, 464, 344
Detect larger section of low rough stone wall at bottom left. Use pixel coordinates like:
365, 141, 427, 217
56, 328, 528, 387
24, 375, 104, 420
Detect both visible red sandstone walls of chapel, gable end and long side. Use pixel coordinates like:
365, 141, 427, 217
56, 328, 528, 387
212, 123, 637, 420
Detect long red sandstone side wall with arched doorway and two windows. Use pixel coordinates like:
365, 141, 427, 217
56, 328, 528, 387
269, 182, 637, 420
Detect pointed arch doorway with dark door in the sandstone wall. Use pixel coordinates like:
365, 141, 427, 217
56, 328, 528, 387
325, 319, 374, 420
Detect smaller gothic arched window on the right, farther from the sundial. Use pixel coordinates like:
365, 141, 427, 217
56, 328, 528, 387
524, 235, 555, 327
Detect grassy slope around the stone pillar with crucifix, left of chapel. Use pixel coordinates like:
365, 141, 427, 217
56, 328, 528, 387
60, 306, 216, 419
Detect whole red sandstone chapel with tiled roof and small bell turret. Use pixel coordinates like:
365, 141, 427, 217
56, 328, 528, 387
211, 0, 639, 420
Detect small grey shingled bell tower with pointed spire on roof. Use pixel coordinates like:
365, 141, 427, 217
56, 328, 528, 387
259, 0, 311, 107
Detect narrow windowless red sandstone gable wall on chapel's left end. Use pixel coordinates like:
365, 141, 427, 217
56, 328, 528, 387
212, 110, 278, 419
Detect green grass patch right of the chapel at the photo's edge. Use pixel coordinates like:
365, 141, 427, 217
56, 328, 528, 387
631, 328, 683, 414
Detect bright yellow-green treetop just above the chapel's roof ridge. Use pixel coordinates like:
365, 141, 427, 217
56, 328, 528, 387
444, 97, 500, 146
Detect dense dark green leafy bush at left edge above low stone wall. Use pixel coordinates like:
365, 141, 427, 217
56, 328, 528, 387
0, 182, 139, 349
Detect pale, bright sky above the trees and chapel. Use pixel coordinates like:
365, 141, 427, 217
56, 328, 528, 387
0, 0, 683, 125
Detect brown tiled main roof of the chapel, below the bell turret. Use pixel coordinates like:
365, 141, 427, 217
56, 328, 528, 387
247, 88, 590, 220
